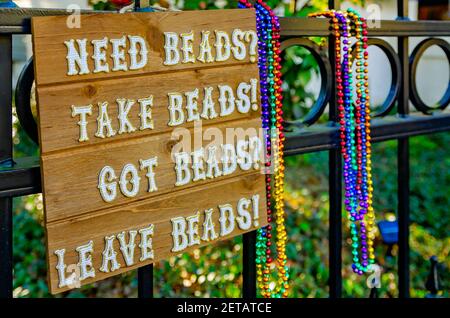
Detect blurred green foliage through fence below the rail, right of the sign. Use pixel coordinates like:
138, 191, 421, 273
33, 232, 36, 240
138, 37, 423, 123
286, 133, 450, 297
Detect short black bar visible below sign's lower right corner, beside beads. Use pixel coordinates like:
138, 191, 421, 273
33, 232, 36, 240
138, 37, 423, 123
242, 231, 256, 299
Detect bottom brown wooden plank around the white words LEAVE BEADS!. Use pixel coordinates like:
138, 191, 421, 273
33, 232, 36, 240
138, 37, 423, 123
47, 174, 267, 293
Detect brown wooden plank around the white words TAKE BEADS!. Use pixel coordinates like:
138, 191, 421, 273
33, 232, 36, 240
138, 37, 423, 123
37, 64, 261, 154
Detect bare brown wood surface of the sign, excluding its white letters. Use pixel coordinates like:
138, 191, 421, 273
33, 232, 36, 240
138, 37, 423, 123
32, 10, 267, 293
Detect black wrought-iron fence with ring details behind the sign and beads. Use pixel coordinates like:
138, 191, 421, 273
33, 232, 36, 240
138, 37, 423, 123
0, 0, 450, 298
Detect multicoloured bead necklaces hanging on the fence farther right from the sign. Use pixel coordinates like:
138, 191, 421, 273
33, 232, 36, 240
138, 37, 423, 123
310, 9, 375, 275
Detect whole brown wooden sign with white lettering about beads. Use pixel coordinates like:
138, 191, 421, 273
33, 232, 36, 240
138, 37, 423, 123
32, 10, 267, 293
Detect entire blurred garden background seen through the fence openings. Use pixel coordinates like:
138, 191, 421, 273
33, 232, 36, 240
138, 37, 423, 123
7, 0, 450, 298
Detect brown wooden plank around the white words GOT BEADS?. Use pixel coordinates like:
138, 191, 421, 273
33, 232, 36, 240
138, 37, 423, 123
42, 118, 261, 222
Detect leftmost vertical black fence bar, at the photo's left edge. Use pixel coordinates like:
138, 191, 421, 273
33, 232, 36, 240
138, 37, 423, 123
0, 35, 13, 298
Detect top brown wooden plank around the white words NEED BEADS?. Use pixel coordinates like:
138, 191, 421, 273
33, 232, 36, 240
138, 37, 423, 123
32, 10, 256, 86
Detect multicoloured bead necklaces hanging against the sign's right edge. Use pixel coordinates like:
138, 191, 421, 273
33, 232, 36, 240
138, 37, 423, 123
239, 0, 289, 298
